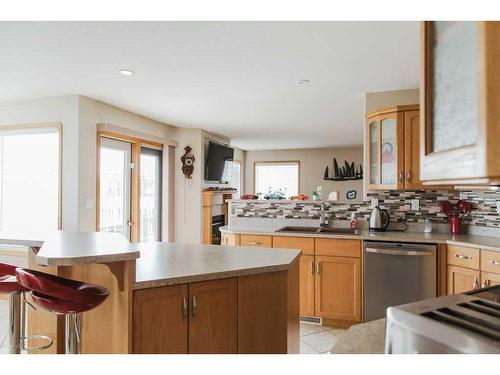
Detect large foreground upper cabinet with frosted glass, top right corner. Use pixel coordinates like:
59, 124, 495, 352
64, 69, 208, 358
420, 22, 500, 185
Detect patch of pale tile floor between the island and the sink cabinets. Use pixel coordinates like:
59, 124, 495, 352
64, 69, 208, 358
300, 322, 345, 354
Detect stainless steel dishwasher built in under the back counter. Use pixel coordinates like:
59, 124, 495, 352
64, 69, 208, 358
363, 241, 437, 321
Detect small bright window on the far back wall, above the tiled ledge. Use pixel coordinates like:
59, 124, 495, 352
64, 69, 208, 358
254, 161, 299, 198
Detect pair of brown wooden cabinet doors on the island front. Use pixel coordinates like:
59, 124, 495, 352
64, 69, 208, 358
133, 278, 238, 354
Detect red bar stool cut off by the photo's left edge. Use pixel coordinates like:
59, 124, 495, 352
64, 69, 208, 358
0, 263, 29, 354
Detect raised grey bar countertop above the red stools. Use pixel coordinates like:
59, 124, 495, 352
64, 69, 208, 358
0, 231, 139, 266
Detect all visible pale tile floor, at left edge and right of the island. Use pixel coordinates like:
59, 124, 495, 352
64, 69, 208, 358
0, 299, 345, 354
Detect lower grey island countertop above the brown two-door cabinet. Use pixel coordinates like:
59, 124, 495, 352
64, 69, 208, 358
134, 242, 301, 289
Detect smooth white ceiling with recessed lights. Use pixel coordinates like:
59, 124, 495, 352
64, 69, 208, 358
0, 22, 419, 149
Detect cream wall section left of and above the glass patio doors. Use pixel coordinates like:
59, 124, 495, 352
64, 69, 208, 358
78, 96, 175, 231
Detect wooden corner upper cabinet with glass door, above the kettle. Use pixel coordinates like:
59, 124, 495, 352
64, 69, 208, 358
365, 104, 422, 190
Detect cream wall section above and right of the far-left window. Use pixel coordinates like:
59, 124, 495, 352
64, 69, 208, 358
0, 96, 79, 230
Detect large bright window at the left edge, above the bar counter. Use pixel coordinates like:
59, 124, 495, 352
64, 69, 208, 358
0, 125, 60, 236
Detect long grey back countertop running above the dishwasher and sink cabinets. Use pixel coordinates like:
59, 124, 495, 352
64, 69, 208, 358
220, 226, 500, 251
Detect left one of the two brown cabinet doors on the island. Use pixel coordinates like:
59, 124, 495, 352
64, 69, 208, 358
133, 284, 188, 354
